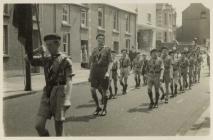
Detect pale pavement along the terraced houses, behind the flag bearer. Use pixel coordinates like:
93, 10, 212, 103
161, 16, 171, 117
3, 63, 89, 99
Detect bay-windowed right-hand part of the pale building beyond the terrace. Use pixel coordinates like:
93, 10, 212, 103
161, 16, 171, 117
156, 3, 176, 43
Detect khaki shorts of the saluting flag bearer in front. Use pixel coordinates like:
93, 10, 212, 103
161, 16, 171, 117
38, 85, 70, 121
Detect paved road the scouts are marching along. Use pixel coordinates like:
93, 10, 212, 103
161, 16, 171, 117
3, 67, 210, 136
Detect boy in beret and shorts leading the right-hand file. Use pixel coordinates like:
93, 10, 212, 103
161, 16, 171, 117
147, 49, 164, 109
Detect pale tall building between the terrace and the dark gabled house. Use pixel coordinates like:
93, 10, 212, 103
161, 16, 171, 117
115, 3, 176, 51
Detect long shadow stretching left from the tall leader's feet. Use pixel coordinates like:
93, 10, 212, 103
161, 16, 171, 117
65, 115, 96, 122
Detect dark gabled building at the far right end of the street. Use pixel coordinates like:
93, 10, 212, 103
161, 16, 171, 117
177, 3, 210, 44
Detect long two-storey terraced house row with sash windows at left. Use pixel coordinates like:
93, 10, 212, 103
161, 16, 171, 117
3, 4, 137, 76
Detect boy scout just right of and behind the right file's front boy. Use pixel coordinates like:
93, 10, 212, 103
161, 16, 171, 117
162, 47, 172, 103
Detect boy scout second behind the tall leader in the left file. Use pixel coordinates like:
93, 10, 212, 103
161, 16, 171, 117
119, 49, 130, 94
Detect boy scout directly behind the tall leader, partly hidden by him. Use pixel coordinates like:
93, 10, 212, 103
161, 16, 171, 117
109, 51, 118, 99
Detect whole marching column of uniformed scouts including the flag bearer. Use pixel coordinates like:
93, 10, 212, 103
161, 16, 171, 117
26, 34, 203, 136
